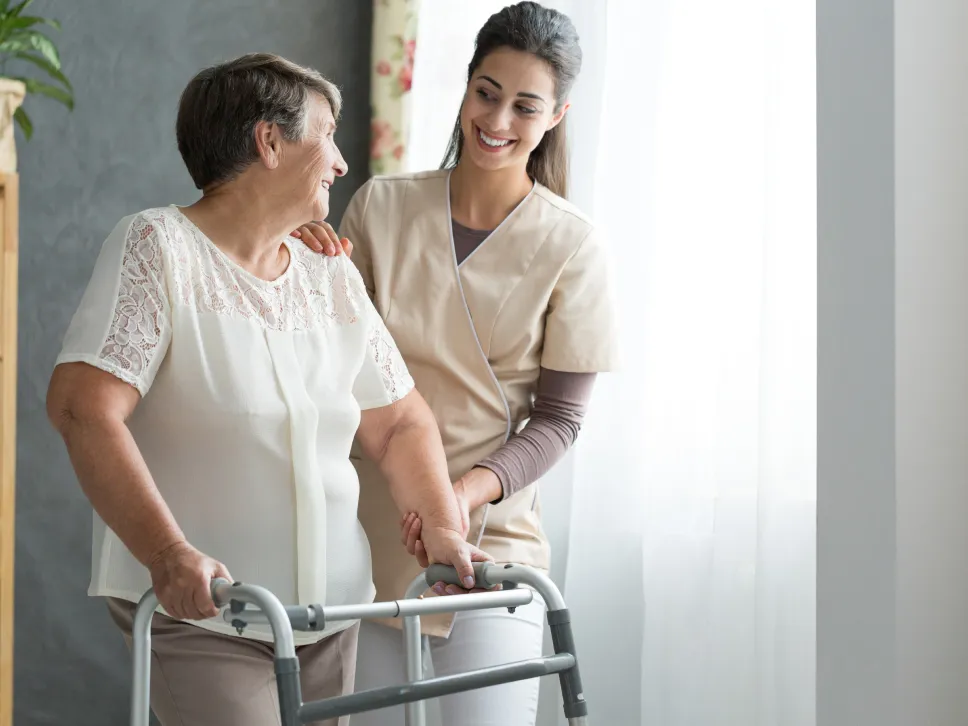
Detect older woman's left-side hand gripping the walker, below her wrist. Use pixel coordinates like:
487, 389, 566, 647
149, 542, 232, 620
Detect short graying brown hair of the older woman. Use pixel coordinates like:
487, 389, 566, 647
175, 53, 343, 190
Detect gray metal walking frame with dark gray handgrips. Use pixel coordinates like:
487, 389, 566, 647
131, 562, 588, 726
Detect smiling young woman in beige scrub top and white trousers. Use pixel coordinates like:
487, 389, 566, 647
298, 2, 617, 726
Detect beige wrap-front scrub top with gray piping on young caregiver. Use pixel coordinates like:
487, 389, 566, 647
339, 171, 618, 637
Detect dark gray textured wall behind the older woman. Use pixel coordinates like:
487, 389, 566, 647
14, 0, 372, 726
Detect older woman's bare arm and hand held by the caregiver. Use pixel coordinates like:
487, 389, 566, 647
357, 390, 489, 582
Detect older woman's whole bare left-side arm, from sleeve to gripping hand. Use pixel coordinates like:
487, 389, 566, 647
47, 363, 232, 619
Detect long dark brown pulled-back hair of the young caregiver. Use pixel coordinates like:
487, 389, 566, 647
441, 2, 582, 197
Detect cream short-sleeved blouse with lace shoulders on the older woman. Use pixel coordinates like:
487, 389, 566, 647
57, 206, 413, 643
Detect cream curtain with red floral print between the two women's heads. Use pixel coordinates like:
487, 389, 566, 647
370, 0, 419, 174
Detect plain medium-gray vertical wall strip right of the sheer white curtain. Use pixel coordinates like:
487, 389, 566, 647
817, 0, 900, 726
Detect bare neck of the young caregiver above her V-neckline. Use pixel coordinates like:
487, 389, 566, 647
450, 161, 533, 229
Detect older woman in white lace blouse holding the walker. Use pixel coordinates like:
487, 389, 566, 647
48, 55, 486, 726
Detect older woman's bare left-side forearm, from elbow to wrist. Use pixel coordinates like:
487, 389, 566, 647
57, 419, 185, 567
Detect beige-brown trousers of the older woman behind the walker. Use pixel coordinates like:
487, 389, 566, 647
107, 598, 360, 726
